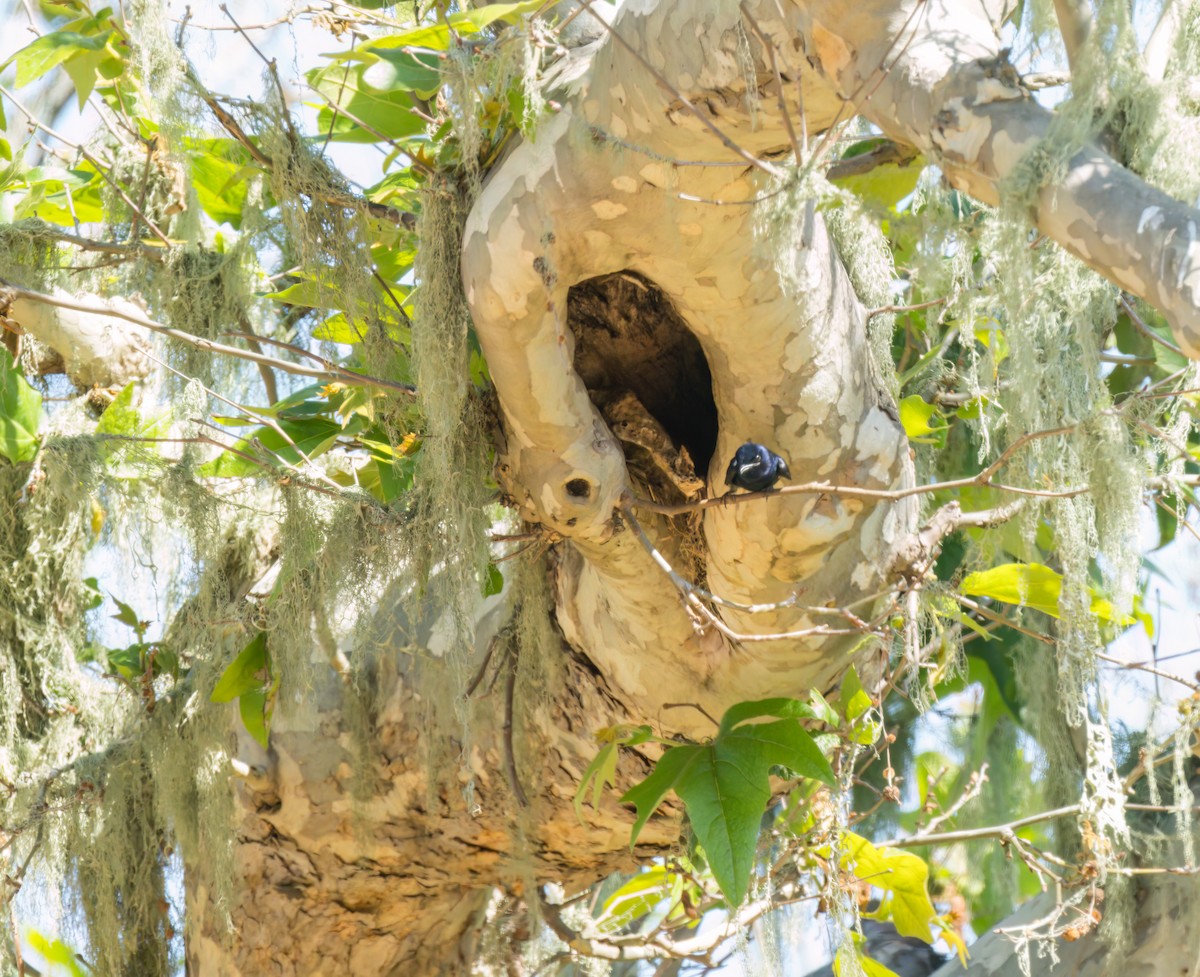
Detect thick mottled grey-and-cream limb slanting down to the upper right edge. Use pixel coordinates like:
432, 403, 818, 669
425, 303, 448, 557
796, 0, 1200, 358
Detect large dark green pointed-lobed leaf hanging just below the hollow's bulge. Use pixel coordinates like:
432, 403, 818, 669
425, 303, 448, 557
622, 719, 834, 905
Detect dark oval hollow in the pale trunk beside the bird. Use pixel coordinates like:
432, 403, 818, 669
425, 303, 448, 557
568, 271, 716, 495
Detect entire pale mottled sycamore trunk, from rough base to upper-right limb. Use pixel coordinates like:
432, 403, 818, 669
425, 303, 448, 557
171, 0, 1200, 975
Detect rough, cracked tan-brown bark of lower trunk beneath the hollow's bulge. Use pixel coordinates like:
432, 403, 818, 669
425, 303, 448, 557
186, 600, 678, 977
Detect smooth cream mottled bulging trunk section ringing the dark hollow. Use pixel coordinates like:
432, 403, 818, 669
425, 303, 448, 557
463, 4, 916, 730
